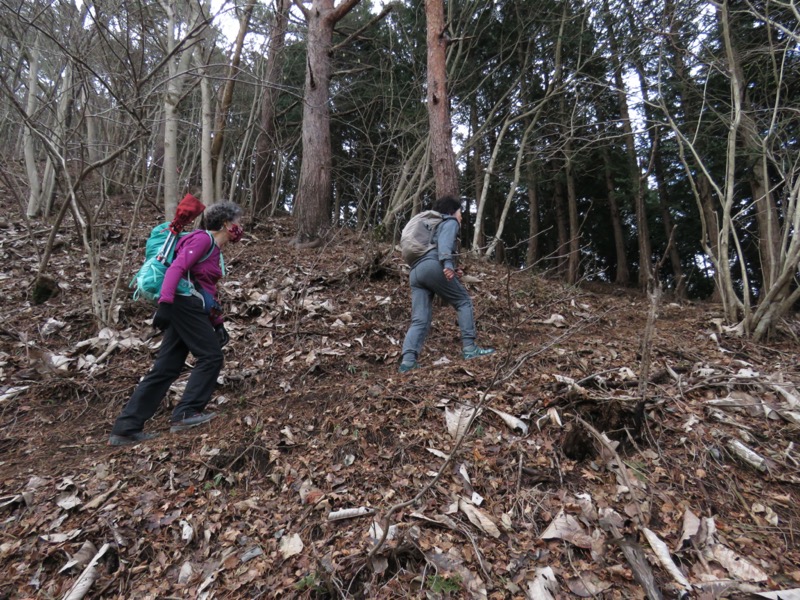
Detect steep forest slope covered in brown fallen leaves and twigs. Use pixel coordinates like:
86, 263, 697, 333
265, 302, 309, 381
0, 199, 800, 599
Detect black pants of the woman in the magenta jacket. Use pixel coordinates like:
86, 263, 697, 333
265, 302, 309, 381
111, 296, 224, 435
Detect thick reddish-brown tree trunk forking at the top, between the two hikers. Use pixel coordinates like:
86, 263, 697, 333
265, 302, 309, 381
294, 0, 359, 246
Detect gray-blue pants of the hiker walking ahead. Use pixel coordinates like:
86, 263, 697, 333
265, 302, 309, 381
403, 259, 475, 363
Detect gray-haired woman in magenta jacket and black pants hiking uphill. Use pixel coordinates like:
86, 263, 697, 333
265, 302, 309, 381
108, 202, 243, 446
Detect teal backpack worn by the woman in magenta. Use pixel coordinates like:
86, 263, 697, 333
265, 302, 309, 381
129, 222, 217, 304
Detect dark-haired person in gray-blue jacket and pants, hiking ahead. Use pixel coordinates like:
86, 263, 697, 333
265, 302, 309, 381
400, 196, 494, 373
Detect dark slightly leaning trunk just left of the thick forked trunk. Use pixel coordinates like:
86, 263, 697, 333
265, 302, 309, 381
253, 0, 292, 214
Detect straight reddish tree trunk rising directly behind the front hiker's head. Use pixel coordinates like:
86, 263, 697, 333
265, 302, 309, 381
425, 0, 459, 197
